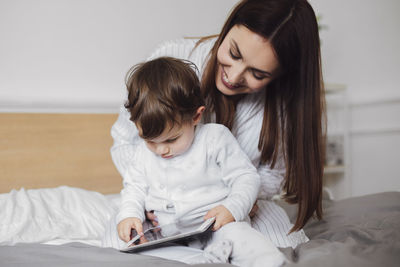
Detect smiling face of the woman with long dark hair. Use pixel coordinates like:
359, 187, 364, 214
215, 25, 279, 95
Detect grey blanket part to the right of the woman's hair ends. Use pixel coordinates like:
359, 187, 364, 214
283, 192, 400, 267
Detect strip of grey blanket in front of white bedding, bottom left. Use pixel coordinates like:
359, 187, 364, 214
0, 243, 232, 267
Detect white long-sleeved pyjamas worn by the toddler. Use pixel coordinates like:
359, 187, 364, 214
103, 124, 285, 267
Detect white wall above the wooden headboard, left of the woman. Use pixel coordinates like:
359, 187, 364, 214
0, 0, 237, 112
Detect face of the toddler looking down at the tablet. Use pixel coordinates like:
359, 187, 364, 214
139, 122, 195, 159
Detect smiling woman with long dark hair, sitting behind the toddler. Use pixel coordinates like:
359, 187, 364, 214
111, 0, 324, 247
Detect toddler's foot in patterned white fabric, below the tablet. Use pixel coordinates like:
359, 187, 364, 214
203, 239, 232, 263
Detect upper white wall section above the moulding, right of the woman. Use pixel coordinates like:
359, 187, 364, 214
310, 0, 400, 103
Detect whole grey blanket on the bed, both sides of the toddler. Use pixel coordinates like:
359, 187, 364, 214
0, 192, 400, 267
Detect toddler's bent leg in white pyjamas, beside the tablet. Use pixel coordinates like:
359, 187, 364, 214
206, 222, 285, 267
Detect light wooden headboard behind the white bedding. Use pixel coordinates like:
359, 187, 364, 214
0, 113, 122, 194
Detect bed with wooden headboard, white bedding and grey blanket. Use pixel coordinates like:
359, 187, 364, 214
0, 113, 400, 267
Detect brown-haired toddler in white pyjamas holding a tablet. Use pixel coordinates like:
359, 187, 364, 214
113, 57, 284, 267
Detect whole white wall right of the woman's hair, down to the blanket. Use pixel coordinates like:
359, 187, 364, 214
310, 0, 400, 198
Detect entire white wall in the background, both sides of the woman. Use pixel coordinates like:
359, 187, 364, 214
0, 0, 400, 197
